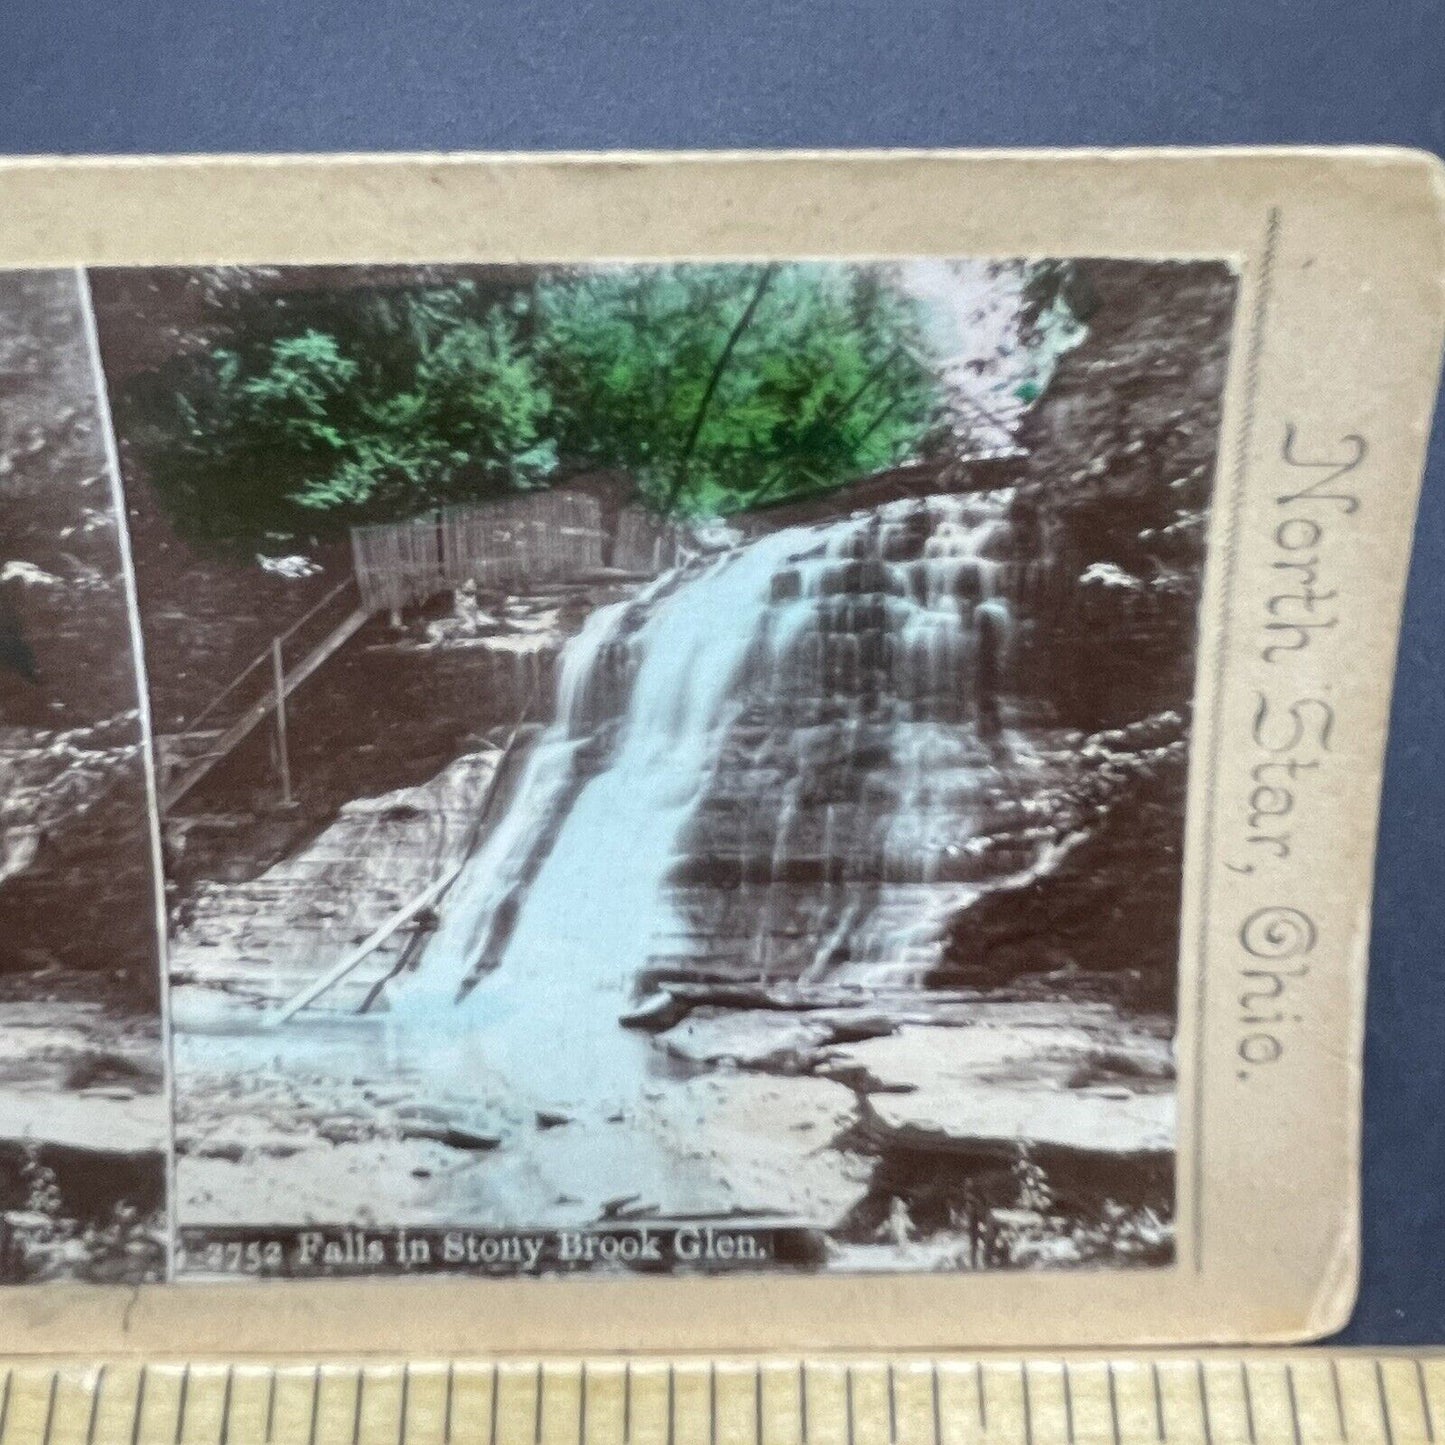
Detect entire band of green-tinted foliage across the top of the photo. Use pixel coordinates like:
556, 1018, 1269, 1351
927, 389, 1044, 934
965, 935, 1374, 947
123, 264, 939, 546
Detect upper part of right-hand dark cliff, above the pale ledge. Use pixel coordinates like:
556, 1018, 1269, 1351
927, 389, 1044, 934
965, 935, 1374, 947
1014, 262, 1237, 731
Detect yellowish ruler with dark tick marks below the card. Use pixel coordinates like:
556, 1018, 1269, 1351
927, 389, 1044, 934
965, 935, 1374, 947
0, 1350, 1445, 1445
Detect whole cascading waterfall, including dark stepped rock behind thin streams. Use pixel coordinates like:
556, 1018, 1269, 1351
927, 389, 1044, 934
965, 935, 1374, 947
396, 493, 1027, 1107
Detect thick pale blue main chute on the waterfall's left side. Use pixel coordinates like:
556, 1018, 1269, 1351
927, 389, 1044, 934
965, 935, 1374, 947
403, 530, 843, 1108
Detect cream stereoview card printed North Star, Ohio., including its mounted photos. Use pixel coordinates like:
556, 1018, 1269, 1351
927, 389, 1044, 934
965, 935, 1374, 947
0, 149, 1445, 1354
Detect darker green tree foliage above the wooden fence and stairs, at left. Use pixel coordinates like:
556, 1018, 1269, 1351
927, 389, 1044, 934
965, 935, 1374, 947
131, 285, 553, 542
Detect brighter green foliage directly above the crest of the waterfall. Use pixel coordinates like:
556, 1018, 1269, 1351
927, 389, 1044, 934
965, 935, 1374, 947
536, 264, 939, 516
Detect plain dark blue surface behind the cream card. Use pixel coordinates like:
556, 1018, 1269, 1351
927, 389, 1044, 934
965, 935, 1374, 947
0, 0, 1445, 1342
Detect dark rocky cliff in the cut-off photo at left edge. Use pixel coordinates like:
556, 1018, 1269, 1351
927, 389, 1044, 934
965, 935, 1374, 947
0, 272, 159, 1006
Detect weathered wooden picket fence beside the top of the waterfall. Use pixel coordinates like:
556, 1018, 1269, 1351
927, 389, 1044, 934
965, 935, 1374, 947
351, 490, 679, 611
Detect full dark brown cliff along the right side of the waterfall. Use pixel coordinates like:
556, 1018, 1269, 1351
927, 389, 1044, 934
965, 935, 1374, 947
948, 262, 1237, 1006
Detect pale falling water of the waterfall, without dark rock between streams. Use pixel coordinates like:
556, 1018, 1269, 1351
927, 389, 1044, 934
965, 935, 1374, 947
393, 497, 1028, 1114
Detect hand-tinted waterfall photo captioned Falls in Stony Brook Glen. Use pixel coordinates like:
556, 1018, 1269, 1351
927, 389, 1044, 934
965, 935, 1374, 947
79, 259, 1235, 1279
